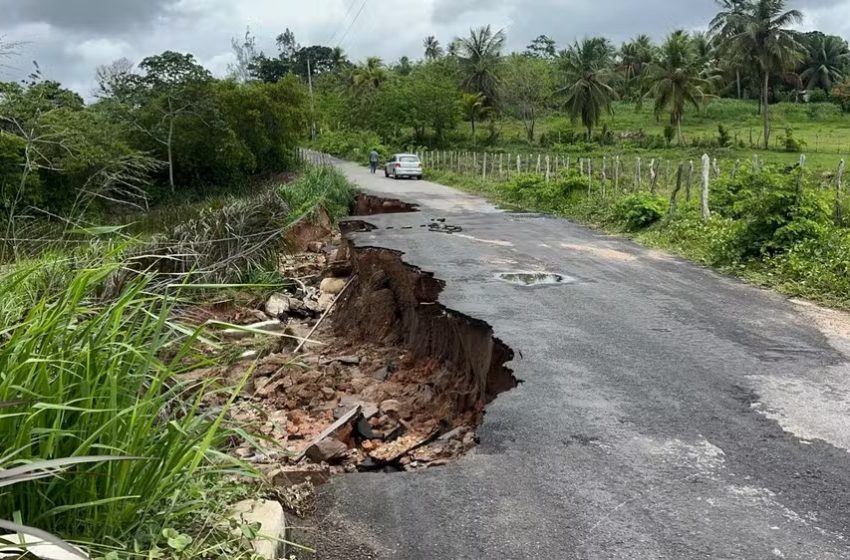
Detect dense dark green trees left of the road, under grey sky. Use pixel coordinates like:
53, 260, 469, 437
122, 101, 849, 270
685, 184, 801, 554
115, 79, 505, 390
0, 52, 308, 217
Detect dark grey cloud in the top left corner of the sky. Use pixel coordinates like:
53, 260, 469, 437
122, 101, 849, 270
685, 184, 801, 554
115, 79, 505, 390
0, 0, 177, 33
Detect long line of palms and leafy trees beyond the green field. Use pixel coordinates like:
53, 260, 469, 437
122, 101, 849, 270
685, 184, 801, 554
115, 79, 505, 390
237, 0, 850, 151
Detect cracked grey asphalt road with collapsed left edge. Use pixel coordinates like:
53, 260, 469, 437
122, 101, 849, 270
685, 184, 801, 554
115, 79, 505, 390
312, 164, 850, 560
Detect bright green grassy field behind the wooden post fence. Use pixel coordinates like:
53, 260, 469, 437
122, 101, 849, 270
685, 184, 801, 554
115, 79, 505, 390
434, 99, 850, 170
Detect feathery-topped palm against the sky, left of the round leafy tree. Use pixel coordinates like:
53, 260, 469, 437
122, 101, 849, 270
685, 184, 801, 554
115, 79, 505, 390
459, 25, 505, 105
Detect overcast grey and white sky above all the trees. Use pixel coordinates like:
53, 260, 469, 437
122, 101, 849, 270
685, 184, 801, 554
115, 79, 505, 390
0, 0, 850, 96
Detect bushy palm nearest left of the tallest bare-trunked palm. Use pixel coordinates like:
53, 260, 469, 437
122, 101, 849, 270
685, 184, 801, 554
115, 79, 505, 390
647, 31, 708, 145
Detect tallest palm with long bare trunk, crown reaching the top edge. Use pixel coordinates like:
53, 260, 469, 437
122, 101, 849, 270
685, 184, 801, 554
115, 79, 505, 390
711, 0, 803, 150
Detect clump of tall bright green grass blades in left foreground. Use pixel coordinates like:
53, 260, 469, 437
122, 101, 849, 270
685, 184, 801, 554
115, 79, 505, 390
0, 246, 242, 540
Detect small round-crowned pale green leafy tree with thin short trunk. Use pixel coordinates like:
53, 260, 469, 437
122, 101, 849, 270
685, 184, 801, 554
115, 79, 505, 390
501, 54, 554, 142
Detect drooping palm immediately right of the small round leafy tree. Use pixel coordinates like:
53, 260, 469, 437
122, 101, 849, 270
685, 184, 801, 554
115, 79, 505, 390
559, 38, 617, 140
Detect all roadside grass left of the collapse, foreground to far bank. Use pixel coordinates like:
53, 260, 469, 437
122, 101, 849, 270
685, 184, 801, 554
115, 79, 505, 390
0, 164, 353, 560
